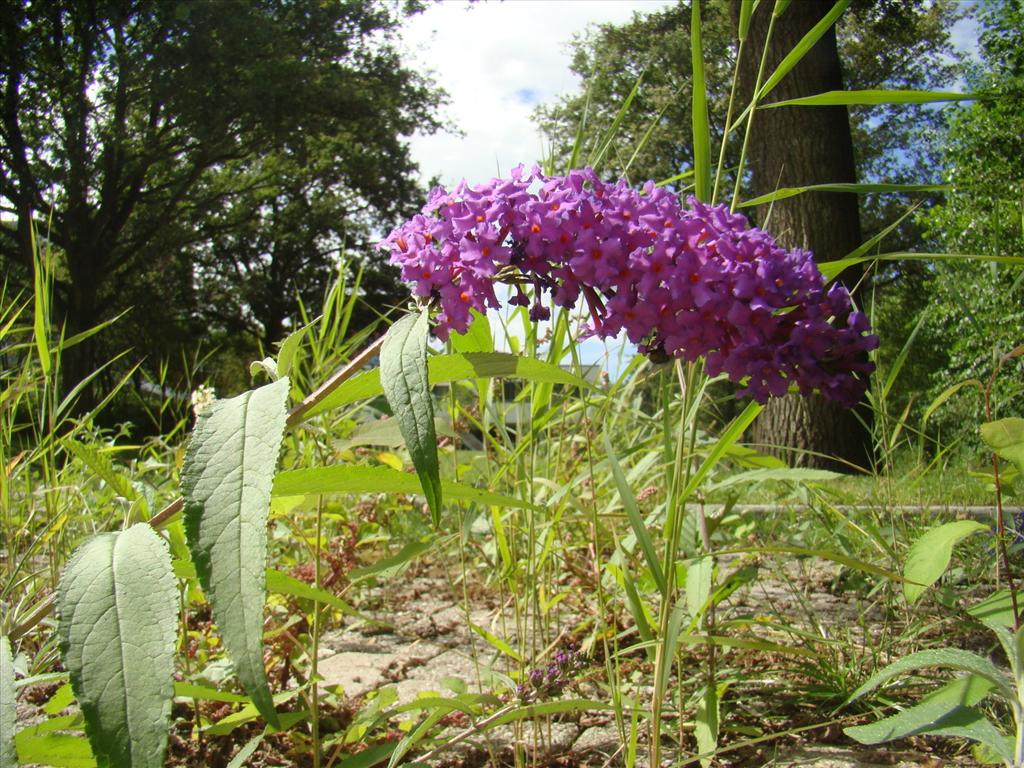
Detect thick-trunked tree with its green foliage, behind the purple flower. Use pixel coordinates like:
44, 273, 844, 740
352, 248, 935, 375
538, 0, 961, 464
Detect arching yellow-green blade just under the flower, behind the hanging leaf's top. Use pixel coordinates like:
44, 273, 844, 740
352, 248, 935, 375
306, 352, 593, 418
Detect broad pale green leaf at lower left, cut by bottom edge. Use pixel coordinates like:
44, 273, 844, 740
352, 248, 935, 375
57, 523, 177, 768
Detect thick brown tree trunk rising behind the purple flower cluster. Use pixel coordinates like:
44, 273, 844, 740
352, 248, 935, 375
733, 0, 870, 471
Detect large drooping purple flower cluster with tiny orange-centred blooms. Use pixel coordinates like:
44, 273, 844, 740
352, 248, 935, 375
381, 166, 878, 406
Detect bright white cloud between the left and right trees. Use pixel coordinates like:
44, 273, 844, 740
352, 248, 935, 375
403, 0, 671, 184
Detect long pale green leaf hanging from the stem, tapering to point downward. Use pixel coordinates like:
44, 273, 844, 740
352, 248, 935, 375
181, 378, 289, 727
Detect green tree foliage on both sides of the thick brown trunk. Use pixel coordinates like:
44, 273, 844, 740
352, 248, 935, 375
537, 0, 963, 234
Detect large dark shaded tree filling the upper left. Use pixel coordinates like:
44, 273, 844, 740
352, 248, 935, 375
0, 0, 439, 404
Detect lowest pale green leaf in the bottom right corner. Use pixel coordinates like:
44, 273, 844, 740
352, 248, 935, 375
844, 675, 1014, 763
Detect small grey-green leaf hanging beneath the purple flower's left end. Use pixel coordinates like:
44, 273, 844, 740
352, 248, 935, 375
380, 311, 442, 527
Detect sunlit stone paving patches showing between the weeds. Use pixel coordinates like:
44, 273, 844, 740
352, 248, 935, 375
309, 574, 972, 768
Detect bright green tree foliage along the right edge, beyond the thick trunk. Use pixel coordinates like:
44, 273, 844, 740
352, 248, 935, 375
905, 0, 1024, 446
